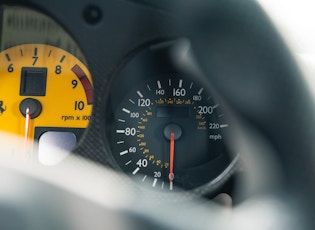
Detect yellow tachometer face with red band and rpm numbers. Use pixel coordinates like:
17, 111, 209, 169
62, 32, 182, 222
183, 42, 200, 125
0, 44, 93, 147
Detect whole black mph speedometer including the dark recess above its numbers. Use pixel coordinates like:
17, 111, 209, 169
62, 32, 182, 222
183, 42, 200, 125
106, 40, 238, 191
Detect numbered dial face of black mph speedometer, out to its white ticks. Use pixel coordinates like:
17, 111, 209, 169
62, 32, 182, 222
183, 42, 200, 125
112, 77, 229, 190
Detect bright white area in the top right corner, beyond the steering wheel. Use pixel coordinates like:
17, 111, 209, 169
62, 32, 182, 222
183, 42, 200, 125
258, 0, 315, 98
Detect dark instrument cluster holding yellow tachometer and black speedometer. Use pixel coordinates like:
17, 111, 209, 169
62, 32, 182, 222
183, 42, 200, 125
0, 1, 239, 198
